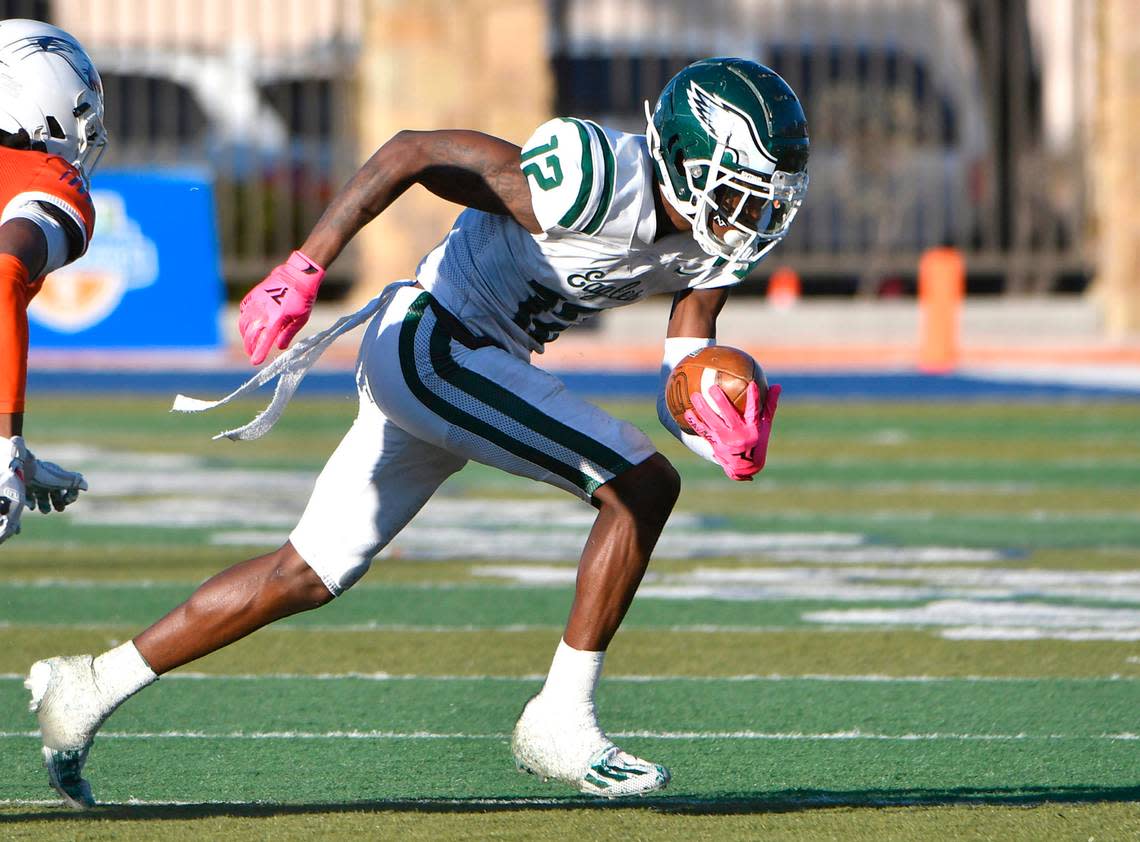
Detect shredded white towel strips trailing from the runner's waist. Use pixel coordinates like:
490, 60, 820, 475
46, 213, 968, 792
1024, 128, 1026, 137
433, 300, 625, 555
171, 287, 391, 441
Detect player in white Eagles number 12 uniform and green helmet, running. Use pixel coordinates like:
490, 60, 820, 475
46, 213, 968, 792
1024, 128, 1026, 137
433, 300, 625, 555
27, 58, 808, 807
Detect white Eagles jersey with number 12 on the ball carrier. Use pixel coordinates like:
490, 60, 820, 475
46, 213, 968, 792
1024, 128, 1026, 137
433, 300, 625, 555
416, 117, 740, 359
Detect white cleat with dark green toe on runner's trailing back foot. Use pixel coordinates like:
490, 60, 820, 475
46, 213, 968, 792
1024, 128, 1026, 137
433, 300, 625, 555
24, 655, 109, 810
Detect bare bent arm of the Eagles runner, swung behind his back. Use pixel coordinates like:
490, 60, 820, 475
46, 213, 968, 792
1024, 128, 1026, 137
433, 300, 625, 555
301, 130, 542, 267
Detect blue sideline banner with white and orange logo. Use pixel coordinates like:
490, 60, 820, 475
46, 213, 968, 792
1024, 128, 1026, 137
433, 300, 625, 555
29, 170, 222, 350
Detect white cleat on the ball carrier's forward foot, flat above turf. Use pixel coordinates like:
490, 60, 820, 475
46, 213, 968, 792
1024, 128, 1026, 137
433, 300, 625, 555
511, 696, 669, 798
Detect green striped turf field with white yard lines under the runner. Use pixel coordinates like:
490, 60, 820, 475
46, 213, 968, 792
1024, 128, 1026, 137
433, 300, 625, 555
0, 395, 1140, 842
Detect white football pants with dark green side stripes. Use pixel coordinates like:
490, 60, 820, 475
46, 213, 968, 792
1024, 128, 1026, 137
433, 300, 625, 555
290, 285, 656, 594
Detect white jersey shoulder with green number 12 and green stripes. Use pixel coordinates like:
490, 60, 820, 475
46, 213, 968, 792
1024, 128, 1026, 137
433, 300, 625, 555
521, 117, 617, 235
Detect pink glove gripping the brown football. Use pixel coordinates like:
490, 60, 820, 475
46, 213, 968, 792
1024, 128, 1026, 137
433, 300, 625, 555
685, 383, 780, 481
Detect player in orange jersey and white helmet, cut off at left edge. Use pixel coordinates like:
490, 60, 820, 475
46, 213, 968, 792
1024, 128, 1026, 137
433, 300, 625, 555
0, 19, 107, 542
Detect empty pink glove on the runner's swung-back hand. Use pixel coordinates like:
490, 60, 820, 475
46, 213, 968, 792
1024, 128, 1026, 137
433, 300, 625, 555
237, 252, 325, 366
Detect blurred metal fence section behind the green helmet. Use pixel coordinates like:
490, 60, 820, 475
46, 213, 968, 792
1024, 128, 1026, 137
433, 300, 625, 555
552, 0, 1092, 295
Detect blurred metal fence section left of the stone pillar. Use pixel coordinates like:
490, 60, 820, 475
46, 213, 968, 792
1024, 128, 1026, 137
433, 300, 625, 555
0, 0, 364, 292
